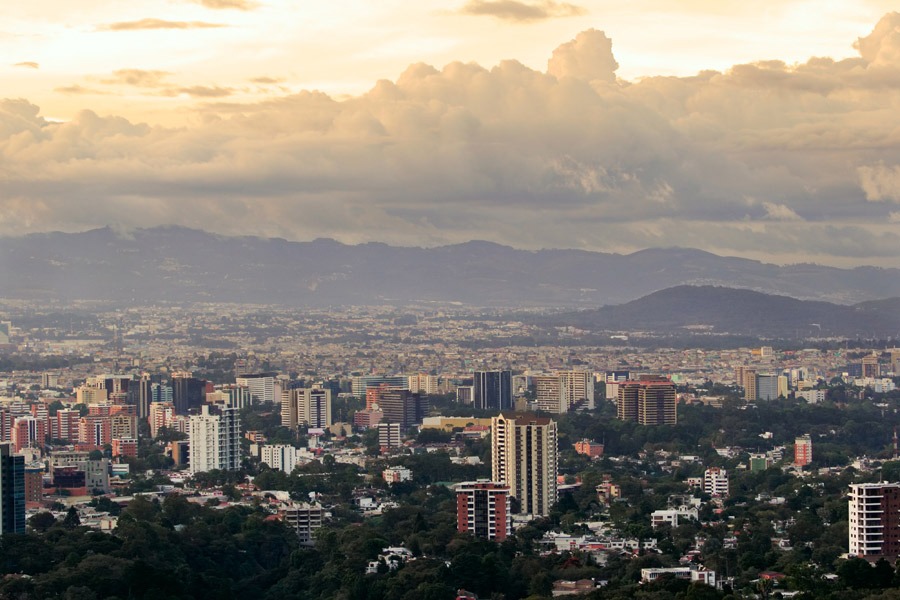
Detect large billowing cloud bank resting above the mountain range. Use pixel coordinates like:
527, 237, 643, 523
0, 15, 900, 265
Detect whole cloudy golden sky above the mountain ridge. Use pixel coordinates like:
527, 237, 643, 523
0, 0, 900, 267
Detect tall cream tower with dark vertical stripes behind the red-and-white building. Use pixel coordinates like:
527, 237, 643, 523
491, 414, 558, 516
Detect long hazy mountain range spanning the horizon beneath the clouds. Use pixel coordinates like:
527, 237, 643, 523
0, 227, 900, 307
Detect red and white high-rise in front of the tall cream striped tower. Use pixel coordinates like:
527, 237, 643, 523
456, 480, 512, 542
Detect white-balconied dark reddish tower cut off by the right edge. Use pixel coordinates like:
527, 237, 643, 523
849, 483, 900, 563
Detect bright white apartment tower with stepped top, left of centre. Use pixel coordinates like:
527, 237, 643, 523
188, 405, 241, 474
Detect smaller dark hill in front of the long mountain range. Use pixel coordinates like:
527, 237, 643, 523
542, 286, 900, 339
